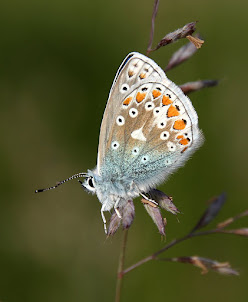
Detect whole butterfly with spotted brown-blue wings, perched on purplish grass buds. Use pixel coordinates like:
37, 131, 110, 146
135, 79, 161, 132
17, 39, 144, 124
36, 52, 203, 232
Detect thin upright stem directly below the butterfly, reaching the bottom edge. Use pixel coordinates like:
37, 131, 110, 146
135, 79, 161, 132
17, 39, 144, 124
115, 229, 128, 302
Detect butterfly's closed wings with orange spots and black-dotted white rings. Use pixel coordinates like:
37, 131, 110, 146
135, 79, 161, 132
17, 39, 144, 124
98, 54, 202, 187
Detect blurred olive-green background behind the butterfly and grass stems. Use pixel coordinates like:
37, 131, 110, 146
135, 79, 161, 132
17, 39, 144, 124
0, 0, 248, 302
